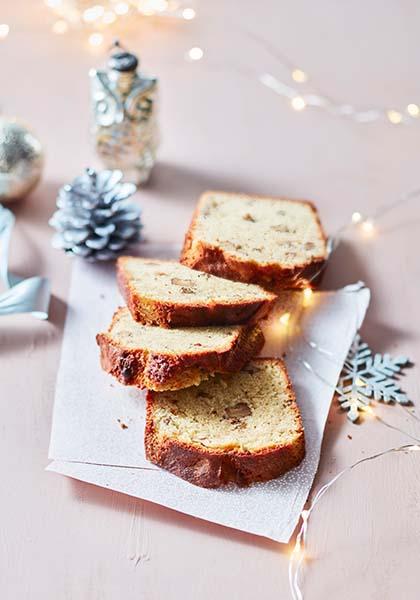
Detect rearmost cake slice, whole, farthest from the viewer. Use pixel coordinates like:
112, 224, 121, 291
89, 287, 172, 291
181, 192, 327, 291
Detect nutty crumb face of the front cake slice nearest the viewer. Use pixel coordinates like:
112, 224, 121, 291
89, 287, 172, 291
153, 360, 302, 452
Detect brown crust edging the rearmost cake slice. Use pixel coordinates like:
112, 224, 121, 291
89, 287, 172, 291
180, 191, 327, 293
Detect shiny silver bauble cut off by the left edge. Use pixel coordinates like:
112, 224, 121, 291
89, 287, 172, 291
0, 117, 44, 202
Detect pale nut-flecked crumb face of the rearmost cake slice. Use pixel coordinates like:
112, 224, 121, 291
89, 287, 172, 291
194, 192, 326, 267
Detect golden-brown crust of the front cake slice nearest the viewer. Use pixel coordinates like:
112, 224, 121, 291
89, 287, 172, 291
145, 358, 305, 488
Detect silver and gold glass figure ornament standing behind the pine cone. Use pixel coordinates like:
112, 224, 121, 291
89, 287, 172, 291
90, 42, 158, 184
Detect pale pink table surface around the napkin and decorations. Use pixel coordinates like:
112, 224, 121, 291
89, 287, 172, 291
0, 0, 420, 600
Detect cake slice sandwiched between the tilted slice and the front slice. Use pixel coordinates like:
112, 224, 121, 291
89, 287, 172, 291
96, 308, 264, 391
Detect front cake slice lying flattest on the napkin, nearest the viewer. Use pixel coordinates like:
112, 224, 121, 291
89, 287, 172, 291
145, 358, 305, 487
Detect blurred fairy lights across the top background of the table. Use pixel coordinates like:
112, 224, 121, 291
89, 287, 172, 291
0, 0, 420, 125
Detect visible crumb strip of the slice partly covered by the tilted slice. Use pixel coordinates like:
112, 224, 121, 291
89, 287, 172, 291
109, 308, 246, 354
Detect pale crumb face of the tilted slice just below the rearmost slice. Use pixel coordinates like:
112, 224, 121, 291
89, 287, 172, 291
121, 257, 271, 306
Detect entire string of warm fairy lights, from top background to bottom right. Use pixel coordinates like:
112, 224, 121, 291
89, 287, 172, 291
0, 0, 420, 600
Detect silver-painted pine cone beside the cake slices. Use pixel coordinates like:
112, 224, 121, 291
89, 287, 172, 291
49, 169, 142, 261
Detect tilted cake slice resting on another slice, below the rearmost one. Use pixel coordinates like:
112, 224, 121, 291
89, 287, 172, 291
117, 256, 276, 327
